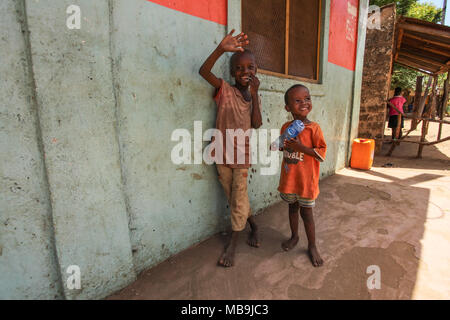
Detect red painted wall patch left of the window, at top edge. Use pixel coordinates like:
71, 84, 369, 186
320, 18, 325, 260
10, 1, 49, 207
147, 0, 227, 26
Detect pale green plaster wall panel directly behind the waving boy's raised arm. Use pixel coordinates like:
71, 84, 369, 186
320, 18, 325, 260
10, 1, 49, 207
107, 1, 227, 271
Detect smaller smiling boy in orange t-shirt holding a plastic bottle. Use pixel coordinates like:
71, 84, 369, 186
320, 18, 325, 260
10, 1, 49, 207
278, 84, 327, 267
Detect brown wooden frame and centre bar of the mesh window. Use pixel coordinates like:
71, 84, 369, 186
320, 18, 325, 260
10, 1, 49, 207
240, 0, 323, 84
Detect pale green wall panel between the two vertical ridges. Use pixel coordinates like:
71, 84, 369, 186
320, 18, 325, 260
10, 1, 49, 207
26, 0, 135, 298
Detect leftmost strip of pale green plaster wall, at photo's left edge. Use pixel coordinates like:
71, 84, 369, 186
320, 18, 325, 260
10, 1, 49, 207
0, 0, 62, 299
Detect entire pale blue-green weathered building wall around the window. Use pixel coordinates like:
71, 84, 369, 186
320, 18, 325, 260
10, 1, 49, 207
0, 0, 367, 299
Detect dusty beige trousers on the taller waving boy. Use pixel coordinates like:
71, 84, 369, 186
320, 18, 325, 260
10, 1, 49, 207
216, 164, 251, 231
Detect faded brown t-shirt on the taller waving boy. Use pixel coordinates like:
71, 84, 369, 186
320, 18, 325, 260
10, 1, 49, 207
214, 79, 261, 168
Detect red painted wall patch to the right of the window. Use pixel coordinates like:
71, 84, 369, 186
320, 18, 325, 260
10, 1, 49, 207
328, 0, 359, 71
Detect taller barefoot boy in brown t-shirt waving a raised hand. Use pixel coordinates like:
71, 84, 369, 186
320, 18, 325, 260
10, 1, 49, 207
199, 29, 262, 267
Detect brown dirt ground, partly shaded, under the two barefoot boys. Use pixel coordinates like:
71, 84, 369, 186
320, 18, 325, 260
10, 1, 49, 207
108, 118, 450, 299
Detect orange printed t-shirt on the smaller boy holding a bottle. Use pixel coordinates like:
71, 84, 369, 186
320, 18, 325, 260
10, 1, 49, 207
278, 121, 327, 199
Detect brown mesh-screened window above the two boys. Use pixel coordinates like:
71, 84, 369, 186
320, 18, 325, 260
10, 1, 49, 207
242, 0, 321, 81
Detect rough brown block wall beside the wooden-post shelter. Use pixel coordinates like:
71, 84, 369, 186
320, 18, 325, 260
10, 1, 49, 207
359, 5, 395, 152
